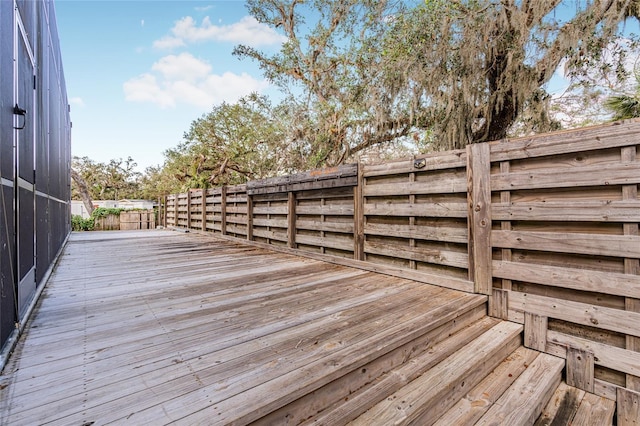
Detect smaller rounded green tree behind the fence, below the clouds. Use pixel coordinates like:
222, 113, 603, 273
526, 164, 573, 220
159, 94, 294, 189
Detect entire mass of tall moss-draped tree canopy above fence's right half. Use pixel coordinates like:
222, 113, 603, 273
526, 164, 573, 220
235, 0, 640, 157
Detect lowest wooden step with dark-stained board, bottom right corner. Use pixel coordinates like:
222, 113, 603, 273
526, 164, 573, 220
535, 382, 616, 426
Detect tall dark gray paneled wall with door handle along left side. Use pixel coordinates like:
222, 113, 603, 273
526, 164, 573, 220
0, 0, 71, 346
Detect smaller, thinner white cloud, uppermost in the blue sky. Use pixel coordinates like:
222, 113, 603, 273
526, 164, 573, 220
153, 16, 286, 49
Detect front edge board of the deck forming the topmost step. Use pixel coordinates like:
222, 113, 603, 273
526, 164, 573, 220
175, 290, 486, 425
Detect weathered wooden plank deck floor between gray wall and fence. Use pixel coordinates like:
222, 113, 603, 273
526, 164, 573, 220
0, 231, 484, 425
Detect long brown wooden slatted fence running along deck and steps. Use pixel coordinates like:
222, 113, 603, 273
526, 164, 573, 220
164, 121, 640, 410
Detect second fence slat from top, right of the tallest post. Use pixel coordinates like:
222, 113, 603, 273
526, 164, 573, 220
491, 163, 640, 191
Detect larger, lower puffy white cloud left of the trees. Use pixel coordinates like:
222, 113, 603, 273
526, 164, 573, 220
123, 53, 268, 109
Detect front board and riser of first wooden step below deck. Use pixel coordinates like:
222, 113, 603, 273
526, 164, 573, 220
350, 321, 524, 425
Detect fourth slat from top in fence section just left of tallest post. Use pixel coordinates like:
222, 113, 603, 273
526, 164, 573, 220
364, 223, 469, 244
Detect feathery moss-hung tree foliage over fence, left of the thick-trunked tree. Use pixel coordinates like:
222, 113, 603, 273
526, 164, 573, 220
234, 0, 412, 167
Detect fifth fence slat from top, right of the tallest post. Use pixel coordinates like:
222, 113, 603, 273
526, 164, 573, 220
492, 260, 640, 299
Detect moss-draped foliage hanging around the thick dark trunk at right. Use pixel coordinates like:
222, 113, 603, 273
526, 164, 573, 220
383, 0, 634, 149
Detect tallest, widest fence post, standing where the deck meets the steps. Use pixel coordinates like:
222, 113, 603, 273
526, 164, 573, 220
467, 143, 493, 295
